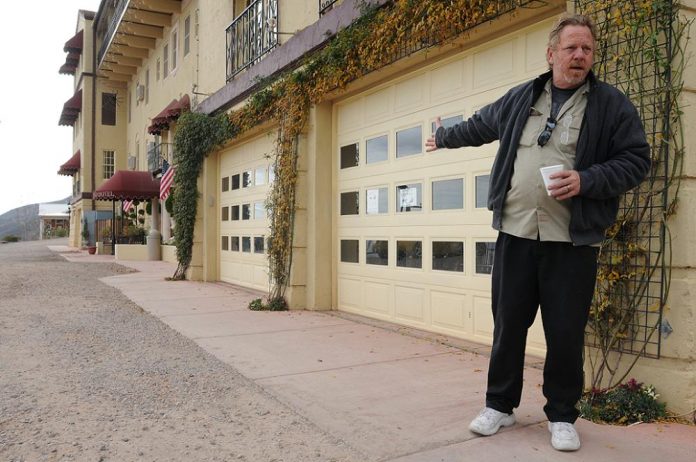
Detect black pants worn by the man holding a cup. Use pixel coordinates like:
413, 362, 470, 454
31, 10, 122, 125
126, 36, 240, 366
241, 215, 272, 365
486, 233, 598, 423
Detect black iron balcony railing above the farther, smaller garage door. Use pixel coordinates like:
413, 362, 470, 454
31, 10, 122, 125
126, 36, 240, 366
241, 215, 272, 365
226, 0, 278, 82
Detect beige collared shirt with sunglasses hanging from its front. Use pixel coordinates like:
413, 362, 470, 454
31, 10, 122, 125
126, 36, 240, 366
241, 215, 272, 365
502, 81, 589, 242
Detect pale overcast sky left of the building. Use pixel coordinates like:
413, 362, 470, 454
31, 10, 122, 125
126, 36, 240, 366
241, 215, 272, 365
0, 0, 100, 215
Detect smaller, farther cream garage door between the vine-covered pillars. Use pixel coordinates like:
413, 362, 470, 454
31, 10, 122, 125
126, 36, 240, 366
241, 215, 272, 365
218, 134, 275, 291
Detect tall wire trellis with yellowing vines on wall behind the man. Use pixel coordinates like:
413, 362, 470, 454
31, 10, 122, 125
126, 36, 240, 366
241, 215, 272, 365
575, 0, 687, 387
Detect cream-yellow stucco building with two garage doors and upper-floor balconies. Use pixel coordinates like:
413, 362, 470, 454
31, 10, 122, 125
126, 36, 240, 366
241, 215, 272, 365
58, 0, 696, 412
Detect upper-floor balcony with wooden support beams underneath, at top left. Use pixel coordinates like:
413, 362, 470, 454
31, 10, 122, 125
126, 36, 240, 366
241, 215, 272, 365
95, 0, 181, 82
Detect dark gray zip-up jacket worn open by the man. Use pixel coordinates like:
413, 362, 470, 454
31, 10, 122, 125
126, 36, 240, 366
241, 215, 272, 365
435, 71, 650, 245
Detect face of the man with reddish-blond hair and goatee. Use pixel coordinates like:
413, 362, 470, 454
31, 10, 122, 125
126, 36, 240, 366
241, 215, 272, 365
546, 26, 594, 88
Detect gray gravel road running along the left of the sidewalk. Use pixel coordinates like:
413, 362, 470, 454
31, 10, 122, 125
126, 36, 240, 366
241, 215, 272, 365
0, 240, 363, 462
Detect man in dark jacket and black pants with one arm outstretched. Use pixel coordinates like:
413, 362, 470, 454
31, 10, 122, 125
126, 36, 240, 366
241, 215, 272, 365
426, 15, 650, 451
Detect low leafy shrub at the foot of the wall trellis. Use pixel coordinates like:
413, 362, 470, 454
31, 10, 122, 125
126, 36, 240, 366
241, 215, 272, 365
579, 379, 667, 425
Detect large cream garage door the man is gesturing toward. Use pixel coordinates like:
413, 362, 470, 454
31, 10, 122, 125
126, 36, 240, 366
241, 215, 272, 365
334, 23, 550, 353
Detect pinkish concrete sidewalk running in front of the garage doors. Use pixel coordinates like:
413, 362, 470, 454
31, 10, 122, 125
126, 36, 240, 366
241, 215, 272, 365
51, 247, 696, 462
